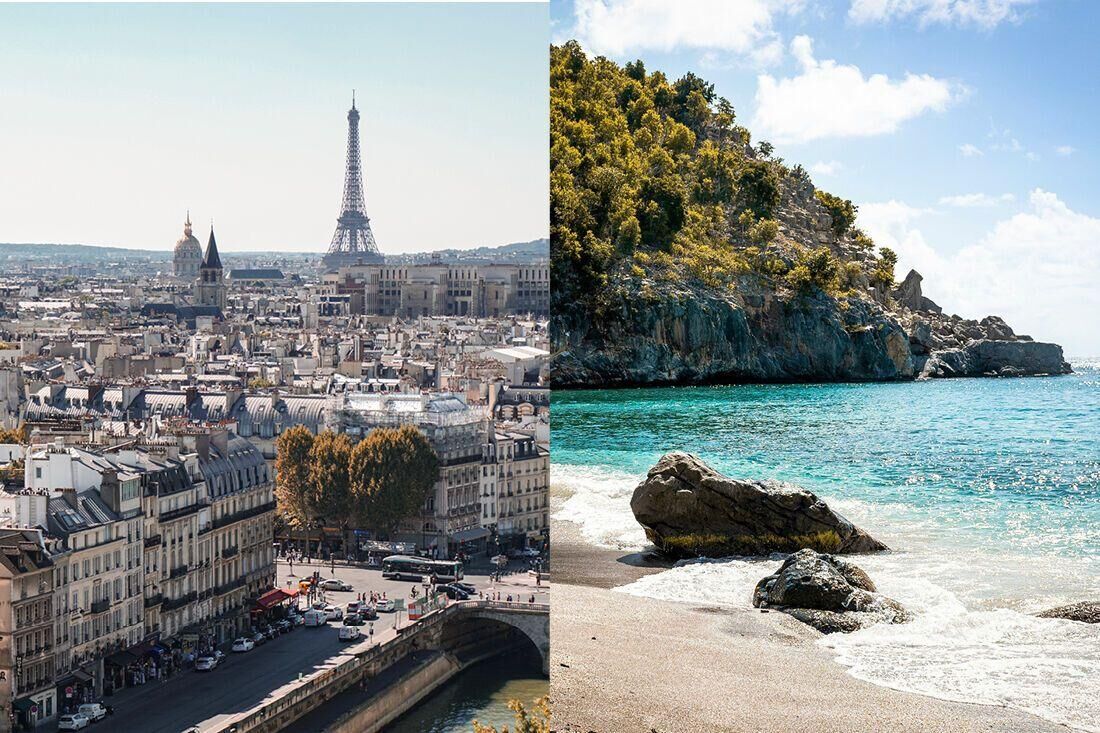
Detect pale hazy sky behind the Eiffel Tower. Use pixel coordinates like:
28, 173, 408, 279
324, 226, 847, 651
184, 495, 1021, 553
0, 3, 549, 253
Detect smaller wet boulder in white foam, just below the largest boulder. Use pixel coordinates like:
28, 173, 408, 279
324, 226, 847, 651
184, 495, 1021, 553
752, 549, 910, 634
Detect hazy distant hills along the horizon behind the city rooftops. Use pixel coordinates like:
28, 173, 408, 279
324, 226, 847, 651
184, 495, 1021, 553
0, 239, 550, 265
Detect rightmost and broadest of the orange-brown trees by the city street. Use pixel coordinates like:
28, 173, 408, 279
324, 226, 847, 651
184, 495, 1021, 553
349, 425, 439, 536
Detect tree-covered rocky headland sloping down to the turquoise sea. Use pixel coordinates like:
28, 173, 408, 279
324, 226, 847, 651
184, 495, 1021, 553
550, 42, 1069, 387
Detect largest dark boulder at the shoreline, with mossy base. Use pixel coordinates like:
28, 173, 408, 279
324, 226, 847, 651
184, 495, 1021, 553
630, 451, 889, 558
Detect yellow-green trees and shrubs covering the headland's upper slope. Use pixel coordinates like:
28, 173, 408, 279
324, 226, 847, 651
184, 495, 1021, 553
550, 41, 884, 310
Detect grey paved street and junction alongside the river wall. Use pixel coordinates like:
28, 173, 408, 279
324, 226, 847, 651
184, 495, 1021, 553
72, 562, 550, 733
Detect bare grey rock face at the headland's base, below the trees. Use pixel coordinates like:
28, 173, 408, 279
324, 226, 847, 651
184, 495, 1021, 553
552, 265, 1070, 387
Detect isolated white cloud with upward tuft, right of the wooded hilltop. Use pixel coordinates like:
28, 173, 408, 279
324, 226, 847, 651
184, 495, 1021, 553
754, 35, 959, 143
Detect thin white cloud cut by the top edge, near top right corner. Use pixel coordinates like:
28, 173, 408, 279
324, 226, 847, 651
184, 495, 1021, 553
848, 0, 1034, 30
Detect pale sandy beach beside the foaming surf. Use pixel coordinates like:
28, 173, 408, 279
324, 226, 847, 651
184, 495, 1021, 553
550, 534, 1070, 733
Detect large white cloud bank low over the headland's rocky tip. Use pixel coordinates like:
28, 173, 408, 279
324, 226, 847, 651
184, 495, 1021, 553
859, 188, 1100, 355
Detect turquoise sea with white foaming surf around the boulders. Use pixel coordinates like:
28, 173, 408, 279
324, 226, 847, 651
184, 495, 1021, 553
552, 361, 1100, 730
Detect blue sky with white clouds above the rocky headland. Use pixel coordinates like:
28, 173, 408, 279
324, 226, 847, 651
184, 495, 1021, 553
550, 0, 1100, 355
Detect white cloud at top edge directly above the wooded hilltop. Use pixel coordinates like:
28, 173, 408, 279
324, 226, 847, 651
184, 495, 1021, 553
572, 0, 804, 63
